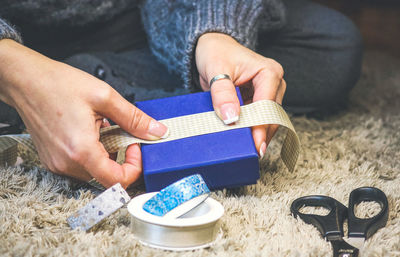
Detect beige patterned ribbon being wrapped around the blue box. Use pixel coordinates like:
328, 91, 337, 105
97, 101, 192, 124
0, 100, 300, 171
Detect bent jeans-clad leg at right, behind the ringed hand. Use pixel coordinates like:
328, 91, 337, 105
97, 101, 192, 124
257, 0, 363, 113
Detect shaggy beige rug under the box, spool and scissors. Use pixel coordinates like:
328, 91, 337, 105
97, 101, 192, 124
0, 53, 400, 257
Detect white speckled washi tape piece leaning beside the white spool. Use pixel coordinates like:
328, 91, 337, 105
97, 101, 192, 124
67, 183, 131, 231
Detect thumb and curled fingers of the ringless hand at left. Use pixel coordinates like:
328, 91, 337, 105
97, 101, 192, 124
86, 84, 155, 188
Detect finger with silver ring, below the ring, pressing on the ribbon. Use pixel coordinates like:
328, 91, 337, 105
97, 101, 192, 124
211, 75, 240, 124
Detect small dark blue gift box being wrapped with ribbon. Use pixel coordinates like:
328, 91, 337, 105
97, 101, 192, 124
136, 89, 260, 192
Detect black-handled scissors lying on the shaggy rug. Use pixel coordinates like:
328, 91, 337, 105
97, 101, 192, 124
290, 187, 389, 257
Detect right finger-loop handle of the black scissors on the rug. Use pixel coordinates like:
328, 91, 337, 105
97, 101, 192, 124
348, 187, 389, 239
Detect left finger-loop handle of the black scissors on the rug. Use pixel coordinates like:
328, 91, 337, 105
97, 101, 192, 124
290, 195, 347, 240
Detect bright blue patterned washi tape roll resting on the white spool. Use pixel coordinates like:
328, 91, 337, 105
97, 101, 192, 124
143, 174, 210, 218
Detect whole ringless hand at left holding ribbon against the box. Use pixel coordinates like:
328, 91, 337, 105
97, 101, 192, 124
0, 39, 168, 187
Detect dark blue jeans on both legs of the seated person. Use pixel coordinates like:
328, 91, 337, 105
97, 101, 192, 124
0, 0, 362, 127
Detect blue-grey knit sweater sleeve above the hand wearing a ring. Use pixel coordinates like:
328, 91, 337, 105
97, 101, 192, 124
141, 0, 285, 89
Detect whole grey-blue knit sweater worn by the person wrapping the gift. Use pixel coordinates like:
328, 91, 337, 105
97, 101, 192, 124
0, 0, 285, 87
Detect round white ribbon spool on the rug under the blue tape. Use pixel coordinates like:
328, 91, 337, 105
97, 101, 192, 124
128, 193, 224, 251
